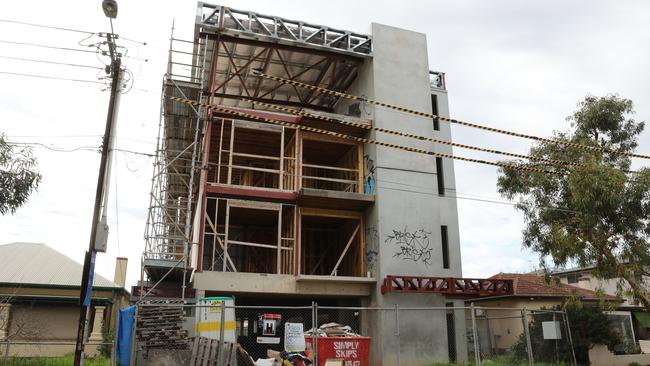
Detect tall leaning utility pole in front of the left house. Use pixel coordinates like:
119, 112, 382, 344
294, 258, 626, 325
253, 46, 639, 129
74, 7, 123, 366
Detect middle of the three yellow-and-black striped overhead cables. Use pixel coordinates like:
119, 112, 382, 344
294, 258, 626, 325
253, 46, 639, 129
242, 98, 583, 167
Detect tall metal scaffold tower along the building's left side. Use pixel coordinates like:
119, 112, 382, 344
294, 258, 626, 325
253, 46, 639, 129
143, 28, 209, 284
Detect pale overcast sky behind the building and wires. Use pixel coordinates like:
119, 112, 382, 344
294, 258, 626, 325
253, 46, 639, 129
0, 0, 650, 285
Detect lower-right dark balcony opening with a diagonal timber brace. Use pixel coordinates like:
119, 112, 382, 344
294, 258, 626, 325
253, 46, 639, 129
300, 209, 365, 277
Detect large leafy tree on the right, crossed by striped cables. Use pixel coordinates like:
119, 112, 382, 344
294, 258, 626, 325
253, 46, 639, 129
497, 95, 650, 310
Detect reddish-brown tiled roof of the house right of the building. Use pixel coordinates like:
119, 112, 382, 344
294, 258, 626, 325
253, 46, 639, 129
490, 273, 616, 300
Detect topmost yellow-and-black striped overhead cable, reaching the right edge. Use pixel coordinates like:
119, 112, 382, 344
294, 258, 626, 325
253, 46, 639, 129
253, 69, 650, 159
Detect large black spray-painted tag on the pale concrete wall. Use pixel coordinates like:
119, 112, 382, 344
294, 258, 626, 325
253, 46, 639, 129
385, 226, 433, 266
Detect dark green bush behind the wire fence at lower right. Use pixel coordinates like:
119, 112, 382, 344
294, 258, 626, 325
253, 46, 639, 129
512, 301, 621, 365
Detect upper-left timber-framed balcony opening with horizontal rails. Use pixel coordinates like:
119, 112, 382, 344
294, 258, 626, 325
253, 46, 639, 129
208, 119, 296, 190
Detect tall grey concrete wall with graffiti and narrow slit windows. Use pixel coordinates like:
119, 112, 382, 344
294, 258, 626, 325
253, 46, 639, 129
353, 24, 466, 365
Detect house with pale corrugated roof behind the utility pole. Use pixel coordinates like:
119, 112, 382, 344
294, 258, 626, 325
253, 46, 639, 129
0, 243, 128, 356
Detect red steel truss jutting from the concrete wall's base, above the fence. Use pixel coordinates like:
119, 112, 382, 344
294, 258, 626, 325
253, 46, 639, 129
381, 275, 513, 298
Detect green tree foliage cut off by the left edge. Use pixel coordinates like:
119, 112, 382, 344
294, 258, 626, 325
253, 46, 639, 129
0, 133, 41, 215
